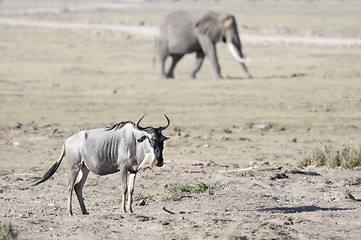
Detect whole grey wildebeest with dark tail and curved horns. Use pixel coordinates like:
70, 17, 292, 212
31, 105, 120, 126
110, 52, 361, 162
35, 115, 170, 215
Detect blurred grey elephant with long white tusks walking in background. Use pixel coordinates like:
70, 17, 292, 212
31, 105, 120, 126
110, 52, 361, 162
155, 11, 252, 79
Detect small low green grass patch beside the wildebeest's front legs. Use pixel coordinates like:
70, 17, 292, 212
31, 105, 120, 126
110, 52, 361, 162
163, 181, 223, 200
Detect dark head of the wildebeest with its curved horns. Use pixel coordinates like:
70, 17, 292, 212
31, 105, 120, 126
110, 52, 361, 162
137, 114, 170, 167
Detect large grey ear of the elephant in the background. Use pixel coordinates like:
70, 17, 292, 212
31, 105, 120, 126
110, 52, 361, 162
195, 13, 223, 42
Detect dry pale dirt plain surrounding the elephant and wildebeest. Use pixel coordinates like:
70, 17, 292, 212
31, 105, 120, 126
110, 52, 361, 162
0, 0, 361, 239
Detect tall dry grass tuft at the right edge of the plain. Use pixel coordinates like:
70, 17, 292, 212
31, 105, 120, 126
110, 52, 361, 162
298, 143, 361, 169
